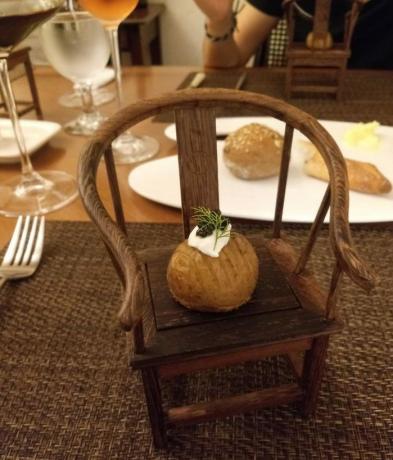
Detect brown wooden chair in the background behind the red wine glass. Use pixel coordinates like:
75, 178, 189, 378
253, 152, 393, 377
0, 47, 43, 120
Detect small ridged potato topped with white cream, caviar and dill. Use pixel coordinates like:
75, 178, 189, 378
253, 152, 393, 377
167, 208, 258, 312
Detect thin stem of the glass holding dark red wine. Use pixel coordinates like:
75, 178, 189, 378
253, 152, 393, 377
0, 58, 34, 176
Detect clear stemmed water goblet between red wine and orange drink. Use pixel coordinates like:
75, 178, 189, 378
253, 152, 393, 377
41, 11, 110, 136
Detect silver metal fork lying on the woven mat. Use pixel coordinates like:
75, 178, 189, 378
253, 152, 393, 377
0, 216, 45, 288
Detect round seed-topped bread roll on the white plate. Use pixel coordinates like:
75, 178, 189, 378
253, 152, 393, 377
224, 123, 283, 179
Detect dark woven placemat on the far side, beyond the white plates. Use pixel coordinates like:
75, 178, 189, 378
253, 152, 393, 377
155, 69, 393, 125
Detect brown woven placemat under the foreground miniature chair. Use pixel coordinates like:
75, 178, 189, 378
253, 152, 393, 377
0, 222, 393, 460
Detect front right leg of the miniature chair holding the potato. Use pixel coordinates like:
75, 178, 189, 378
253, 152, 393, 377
302, 336, 329, 417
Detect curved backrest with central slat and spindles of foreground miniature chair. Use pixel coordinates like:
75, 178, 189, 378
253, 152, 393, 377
78, 89, 374, 329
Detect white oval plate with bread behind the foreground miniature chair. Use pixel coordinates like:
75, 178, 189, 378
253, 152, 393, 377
128, 117, 393, 223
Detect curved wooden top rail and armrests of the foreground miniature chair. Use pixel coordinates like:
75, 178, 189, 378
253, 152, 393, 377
79, 88, 376, 302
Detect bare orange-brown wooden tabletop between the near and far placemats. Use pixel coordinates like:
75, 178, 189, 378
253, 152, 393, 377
0, 67, 188, 247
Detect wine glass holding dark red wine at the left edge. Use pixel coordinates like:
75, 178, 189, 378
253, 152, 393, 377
0, 0, 78, 217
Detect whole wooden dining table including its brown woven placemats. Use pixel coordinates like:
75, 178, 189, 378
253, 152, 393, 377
0, 66, 393, 459
